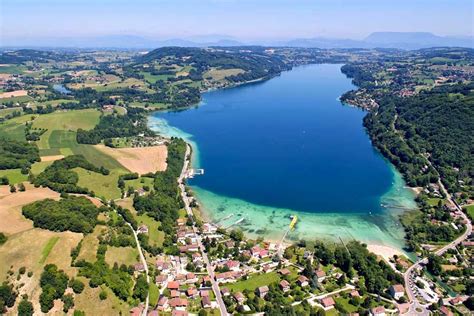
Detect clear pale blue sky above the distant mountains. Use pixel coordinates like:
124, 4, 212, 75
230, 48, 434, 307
0, 0, 474, 40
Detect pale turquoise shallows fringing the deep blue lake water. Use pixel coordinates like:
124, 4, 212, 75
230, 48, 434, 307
148, 64, 413, 251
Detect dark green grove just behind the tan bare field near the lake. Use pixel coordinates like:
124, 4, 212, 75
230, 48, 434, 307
76, 108, 154, 144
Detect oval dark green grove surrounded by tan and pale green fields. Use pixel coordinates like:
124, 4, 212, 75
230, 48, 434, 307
22, 195, 105, 234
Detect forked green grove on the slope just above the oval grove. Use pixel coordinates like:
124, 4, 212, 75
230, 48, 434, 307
31, 155, 109, 194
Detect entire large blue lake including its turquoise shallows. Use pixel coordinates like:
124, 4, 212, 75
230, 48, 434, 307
150, 65, 415, 248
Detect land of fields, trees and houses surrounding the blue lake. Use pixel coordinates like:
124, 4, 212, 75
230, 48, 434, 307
0, 43, 474, 316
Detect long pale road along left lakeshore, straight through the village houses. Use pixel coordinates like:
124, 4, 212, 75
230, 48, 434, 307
178, 144, 229, 316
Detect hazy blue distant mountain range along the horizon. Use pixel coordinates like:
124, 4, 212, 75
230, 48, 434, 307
0, 32, 474, 49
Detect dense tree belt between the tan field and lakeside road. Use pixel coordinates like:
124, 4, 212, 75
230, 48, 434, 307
133, 138, 186, 247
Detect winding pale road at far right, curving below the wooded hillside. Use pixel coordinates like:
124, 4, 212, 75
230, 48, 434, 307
404, 180, 472, 315
